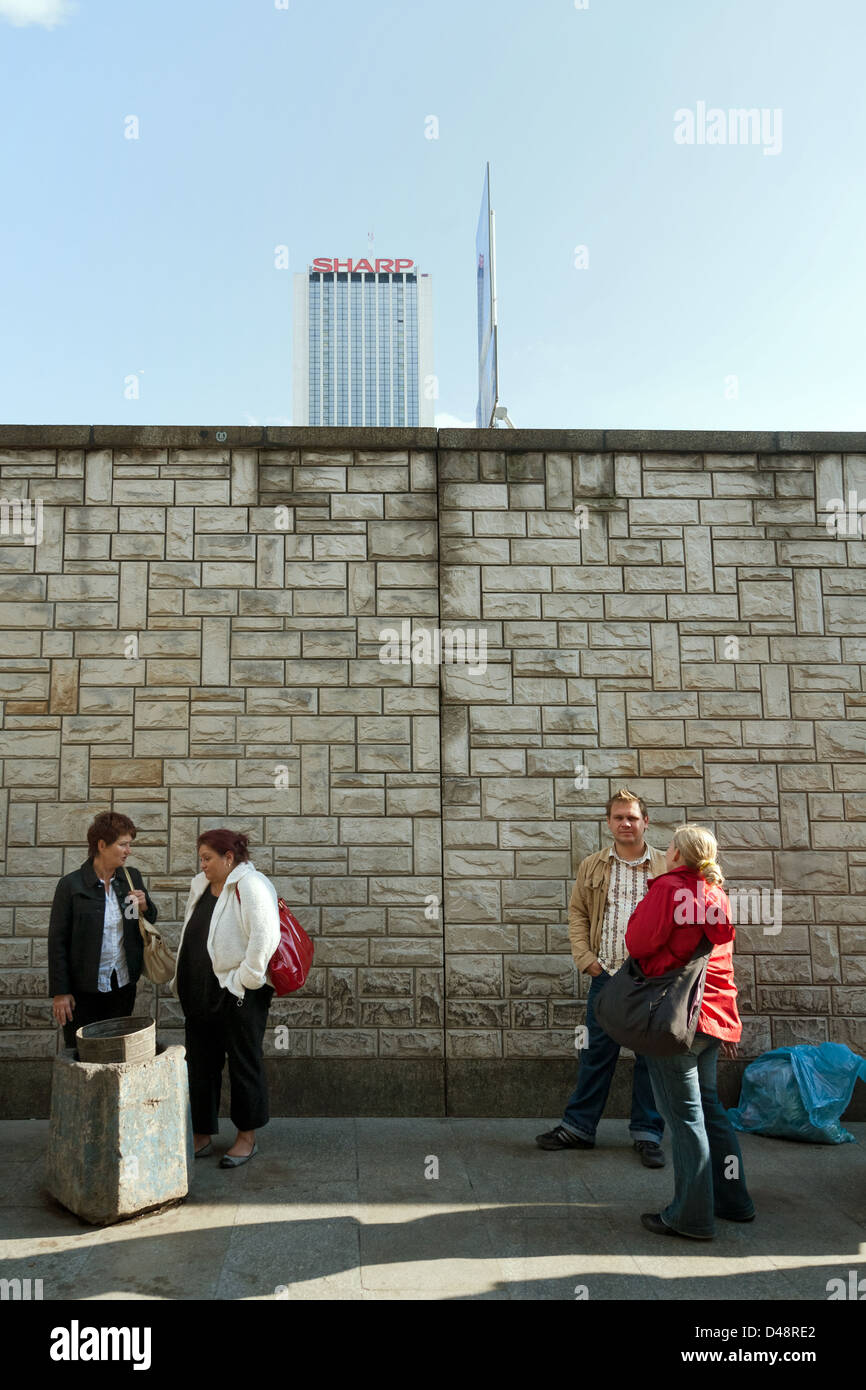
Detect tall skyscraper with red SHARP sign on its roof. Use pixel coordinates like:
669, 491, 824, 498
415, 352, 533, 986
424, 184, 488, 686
292, 256, 436, 425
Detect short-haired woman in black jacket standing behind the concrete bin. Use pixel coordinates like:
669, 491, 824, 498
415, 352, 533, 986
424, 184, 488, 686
49, 810, 157, 1047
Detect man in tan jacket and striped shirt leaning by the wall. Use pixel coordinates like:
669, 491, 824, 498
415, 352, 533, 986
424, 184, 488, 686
535, 787, 667, 1168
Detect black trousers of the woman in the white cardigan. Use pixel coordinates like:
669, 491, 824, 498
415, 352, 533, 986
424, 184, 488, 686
186, 984, 274, 1134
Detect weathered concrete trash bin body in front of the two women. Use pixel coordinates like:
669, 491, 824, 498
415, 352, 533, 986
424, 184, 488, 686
46, 1047, 195, 1226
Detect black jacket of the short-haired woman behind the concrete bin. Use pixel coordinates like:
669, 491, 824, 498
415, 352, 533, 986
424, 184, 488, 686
49, 859, 157, 995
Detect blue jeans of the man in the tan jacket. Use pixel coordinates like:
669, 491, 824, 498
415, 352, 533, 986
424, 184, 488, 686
562, 970, 664, 1144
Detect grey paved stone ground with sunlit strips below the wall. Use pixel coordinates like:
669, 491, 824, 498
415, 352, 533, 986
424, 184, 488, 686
0, 1118, 866, 1301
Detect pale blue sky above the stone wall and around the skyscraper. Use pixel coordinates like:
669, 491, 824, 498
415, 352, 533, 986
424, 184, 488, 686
0, 0, 866, 430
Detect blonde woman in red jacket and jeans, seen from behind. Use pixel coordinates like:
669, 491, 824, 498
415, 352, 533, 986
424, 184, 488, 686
626, 826, 755, 1240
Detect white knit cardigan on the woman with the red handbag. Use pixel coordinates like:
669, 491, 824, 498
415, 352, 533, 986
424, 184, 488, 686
171, 860, 279, 999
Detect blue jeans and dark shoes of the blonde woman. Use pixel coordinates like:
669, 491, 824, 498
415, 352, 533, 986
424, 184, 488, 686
648, 1033, 755, 1236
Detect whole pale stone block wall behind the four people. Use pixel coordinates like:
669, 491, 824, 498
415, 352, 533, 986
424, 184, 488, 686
0, 427, 866, 1113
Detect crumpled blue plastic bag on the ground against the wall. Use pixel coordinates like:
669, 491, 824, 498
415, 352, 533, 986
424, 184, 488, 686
728, 1043, 866, 1144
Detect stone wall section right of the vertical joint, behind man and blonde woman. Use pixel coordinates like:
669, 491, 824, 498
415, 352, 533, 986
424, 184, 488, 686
439, 436, 866, 1058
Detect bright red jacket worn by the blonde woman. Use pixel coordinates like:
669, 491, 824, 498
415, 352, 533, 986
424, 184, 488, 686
626, 869, 742, 1043
